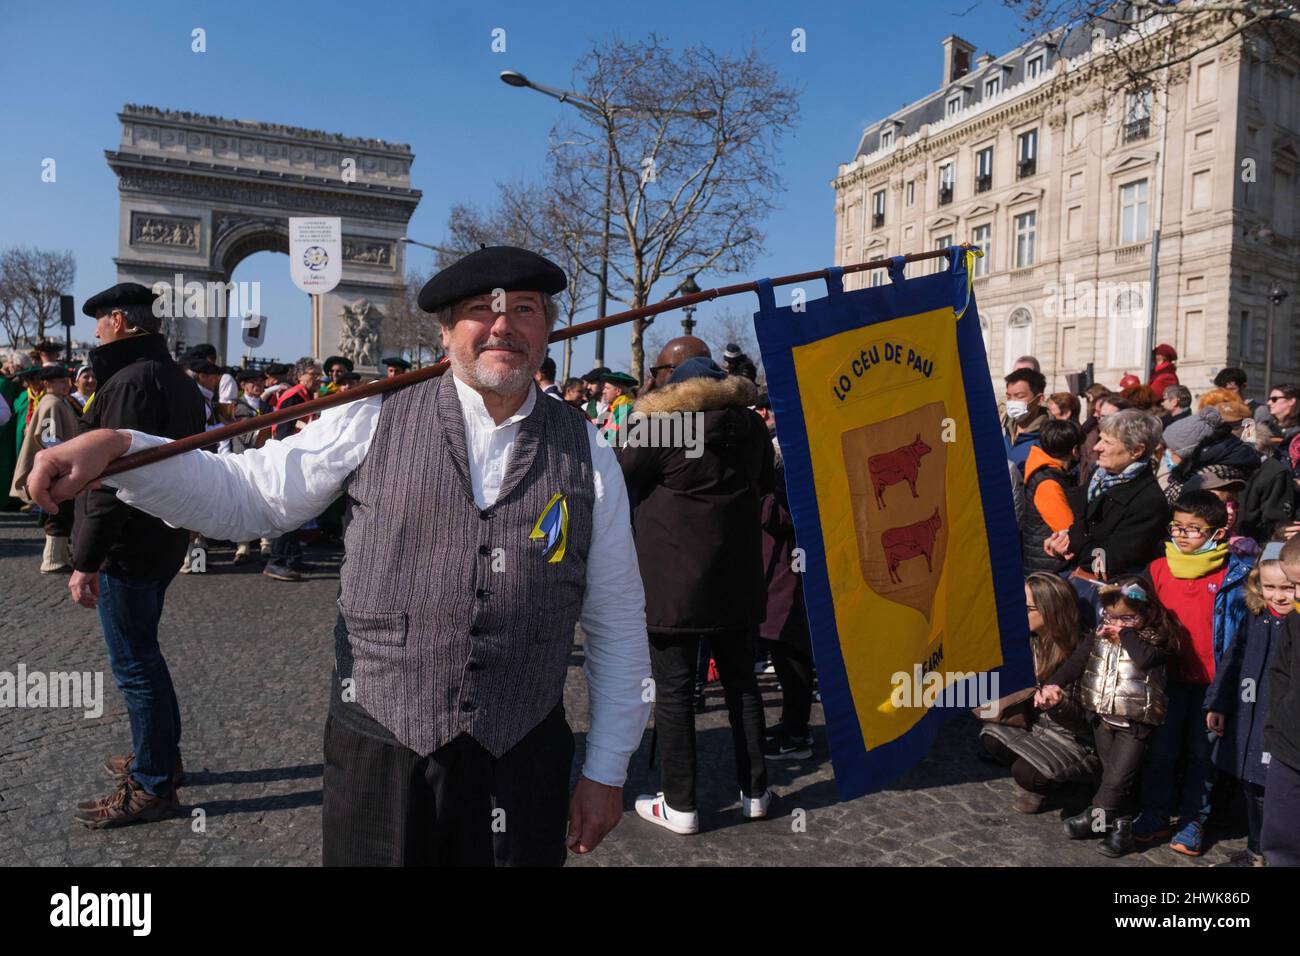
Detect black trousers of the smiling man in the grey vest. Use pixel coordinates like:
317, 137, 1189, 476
321, 692, 573, 866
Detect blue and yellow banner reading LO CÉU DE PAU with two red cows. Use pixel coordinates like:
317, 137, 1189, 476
754, 247, 1034, 800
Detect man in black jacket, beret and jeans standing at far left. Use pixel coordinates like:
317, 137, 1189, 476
57, 282, 204, 829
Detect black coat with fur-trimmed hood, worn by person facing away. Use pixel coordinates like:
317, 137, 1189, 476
618, 376, 774, 633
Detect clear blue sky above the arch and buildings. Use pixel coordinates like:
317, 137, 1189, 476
0, 0, 1024, 373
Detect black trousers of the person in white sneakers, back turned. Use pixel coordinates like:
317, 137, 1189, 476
650, 631, 767, 813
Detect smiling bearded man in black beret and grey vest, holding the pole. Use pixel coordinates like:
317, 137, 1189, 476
29, 246, 653, 865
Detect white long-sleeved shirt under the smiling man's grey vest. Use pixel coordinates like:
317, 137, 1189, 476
104, 377, 653, 787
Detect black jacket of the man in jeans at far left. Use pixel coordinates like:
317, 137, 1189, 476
73, 332, 207, 580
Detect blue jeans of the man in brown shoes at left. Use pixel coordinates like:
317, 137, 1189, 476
99, 572, 181, 796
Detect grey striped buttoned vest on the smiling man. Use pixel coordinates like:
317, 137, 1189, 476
334, 373, 595, 757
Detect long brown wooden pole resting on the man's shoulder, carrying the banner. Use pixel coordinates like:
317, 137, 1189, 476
100, 245, 966, 477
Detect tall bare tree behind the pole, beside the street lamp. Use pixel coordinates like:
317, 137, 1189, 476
551, 35, 798, 378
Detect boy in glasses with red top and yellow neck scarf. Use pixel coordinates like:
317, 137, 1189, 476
1134, 490, 1251, 856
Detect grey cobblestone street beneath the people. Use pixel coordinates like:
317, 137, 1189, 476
0, 514, 1245, 866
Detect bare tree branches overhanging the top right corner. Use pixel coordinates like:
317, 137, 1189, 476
1002, 0, 1300, 90
